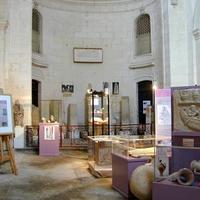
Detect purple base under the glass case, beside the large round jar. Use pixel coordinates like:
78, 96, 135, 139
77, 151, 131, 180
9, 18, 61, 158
112, 154, 147, 198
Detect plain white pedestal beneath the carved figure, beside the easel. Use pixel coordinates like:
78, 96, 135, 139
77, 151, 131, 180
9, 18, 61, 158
14, 126, 24, 149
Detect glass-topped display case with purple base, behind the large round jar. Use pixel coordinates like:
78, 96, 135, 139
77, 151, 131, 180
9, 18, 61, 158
112, 135, 155, 199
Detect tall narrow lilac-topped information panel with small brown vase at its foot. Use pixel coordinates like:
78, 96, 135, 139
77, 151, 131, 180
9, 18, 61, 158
154, 89, 172, 179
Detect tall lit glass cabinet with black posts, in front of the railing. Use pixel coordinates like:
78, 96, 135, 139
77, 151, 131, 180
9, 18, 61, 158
86, 91, 109, 136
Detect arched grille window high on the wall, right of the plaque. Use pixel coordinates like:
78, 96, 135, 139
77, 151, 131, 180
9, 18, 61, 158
136, 14, 151, 55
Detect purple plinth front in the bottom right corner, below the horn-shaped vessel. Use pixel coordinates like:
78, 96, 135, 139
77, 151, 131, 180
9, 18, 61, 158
153, 180, 200, 200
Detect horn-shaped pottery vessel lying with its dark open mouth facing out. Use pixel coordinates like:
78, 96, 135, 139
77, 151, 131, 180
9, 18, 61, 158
168, 168, 194, 186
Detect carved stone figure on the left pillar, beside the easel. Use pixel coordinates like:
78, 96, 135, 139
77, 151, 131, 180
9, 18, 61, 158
13, 99, 24, 126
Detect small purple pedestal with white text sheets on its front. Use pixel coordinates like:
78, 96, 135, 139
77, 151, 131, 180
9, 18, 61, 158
39, 123, 60, 156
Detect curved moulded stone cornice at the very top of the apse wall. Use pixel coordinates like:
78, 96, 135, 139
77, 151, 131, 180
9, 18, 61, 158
33, 0, 155, 13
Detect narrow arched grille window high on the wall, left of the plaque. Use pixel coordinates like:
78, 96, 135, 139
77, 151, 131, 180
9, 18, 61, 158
32, 9, 41, 53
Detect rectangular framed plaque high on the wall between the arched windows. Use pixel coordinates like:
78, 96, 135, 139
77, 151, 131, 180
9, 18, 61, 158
73, 47, 103, 63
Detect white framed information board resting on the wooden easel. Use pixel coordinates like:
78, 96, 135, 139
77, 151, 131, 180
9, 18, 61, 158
0, 95, 14, 135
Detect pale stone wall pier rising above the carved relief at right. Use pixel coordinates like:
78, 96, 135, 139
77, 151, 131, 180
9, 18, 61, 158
162, 0, 196, 86
